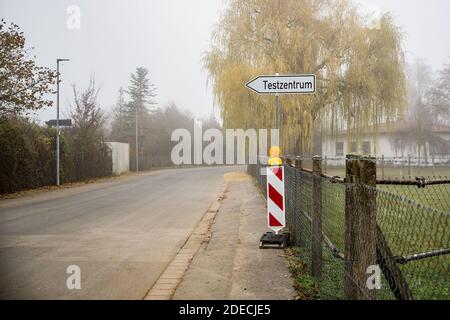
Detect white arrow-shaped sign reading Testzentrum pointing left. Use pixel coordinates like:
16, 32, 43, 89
245, 74, 316, 94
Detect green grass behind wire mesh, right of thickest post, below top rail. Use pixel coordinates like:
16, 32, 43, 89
377, 186, 450, 300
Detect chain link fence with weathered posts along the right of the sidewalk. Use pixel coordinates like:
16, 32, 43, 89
248, 157, 450, 300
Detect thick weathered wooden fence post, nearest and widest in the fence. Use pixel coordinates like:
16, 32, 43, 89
344, 155, 377, 300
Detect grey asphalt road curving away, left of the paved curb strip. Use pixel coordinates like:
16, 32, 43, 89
0, 167, 240, 299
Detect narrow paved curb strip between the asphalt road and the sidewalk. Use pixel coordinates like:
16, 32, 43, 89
144, 181, 228, 300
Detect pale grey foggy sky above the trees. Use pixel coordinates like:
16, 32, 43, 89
0, 0, 450, 124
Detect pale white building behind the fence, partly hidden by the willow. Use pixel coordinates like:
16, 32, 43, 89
322, 125, 450, 165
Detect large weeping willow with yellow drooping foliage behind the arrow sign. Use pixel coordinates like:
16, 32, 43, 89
203, 0, 405, 154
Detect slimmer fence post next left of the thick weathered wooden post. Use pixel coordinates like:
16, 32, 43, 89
311, 156, 322, 279
